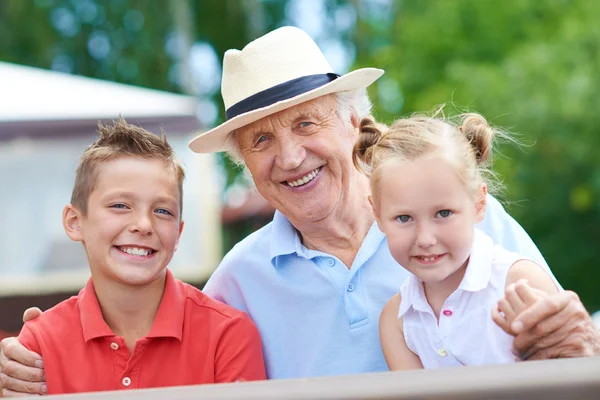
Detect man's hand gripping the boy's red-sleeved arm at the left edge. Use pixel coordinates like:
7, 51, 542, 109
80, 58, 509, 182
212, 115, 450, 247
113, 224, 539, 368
0, 308, 47, 397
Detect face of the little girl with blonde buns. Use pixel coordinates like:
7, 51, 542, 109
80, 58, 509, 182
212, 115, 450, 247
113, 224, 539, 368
371, 156, 486, 286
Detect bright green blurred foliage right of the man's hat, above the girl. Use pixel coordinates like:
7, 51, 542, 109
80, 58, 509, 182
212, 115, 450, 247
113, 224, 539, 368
357, 0, 600, 310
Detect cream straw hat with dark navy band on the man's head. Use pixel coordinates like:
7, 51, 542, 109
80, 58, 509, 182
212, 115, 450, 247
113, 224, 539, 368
189, 26, 383, 153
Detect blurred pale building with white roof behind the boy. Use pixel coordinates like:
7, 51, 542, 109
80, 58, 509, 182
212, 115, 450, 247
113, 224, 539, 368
0, 62, 222, 332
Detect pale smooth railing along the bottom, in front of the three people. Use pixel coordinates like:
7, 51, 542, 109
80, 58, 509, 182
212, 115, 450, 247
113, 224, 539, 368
51, 357, 600, 400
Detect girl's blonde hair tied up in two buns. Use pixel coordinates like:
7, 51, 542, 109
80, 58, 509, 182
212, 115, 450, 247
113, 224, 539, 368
352, 113, 505, 202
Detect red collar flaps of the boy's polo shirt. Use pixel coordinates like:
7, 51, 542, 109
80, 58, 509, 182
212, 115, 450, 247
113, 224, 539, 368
77, 269, 187, 342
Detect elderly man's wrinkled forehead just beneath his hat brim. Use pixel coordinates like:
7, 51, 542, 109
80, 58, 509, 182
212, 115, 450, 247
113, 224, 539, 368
237, 95, 337, 134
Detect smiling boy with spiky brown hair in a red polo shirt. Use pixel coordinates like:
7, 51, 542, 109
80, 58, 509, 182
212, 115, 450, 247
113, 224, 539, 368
19, 119, 265, 394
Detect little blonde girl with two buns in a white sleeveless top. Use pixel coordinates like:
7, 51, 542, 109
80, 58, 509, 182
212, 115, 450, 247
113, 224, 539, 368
354, 114, 558, 370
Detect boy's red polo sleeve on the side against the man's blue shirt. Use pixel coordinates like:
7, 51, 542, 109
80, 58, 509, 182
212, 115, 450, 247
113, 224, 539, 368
215, 314, 267, 383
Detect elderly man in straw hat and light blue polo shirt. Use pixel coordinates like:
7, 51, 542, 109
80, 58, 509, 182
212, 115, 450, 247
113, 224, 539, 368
0, 27, 600, 394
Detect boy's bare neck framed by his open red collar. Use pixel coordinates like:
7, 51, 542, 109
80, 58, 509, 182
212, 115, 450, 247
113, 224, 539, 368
93, 271, 166, 353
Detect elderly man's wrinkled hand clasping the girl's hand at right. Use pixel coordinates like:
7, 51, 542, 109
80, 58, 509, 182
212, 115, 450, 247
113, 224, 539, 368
493, 282, 600, 360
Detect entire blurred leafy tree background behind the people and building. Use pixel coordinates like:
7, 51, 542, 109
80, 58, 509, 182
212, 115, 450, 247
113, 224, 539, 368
0, 0, 600, 311
